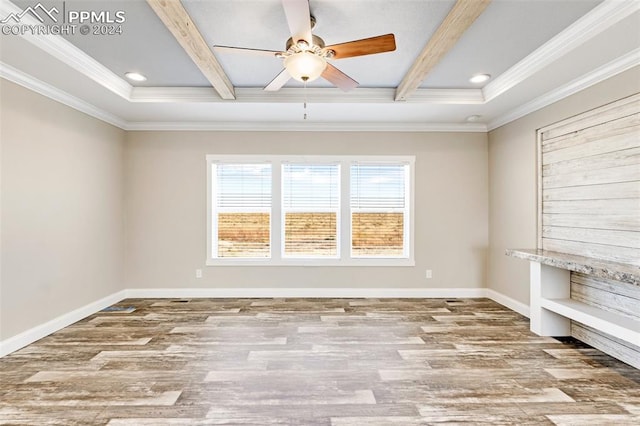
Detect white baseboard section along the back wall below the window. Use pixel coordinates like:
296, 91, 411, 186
126, 287, 486, 299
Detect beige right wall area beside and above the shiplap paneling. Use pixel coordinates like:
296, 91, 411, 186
487, 67, 640, 305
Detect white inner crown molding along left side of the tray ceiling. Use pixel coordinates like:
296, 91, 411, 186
0, 0, 132, 100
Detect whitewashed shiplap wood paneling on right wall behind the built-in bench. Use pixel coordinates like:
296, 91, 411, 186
538, 94, 640, 368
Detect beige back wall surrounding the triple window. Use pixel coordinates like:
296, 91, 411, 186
125, 132, 488, 288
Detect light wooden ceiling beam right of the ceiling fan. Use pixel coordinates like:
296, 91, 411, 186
395, 0, 491, 101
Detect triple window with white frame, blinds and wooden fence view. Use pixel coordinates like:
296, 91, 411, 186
207, 155, 414, 266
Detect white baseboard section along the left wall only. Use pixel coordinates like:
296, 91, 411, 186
0, 290, 126, 357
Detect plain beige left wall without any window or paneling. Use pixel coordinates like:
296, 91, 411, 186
0, 79, 125, 340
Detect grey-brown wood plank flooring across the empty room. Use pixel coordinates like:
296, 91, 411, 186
0, 299, 640, 426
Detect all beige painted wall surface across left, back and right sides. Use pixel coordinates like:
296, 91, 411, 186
0, 62, 640, 340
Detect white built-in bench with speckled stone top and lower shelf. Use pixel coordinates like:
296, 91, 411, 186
506, 249, 640, 346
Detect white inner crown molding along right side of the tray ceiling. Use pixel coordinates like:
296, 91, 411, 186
483, 0, 640, 102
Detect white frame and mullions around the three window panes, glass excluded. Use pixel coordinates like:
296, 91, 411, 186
205, 155, 415, 266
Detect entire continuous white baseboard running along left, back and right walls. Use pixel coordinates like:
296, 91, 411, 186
0, 288, 529, 358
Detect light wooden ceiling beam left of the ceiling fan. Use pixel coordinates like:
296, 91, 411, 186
147, 0, 236, 99
